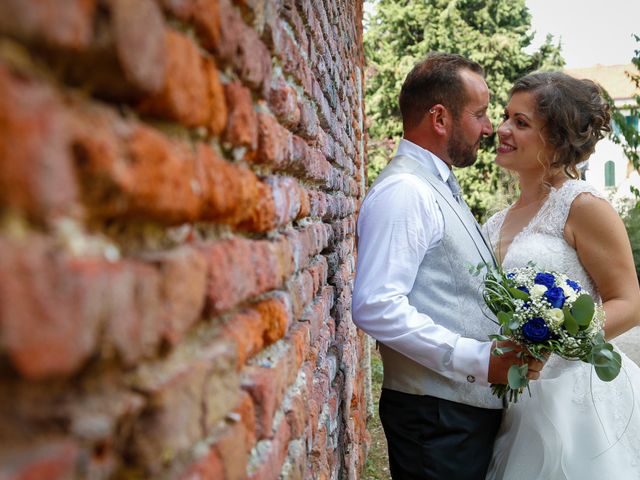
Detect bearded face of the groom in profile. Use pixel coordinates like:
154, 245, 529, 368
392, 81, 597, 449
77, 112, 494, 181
447, 69, 493, 167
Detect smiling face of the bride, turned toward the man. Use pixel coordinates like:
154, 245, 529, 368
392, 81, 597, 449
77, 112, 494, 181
496, 92, 550, 173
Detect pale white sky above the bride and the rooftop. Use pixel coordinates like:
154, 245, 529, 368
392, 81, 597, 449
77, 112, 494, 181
526, 0, 640, 68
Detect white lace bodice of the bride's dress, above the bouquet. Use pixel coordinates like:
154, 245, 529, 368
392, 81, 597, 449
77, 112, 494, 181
484, 180, 604, 298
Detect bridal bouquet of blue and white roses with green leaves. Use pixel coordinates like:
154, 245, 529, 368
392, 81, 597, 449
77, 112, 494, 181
483, 264, 621, 402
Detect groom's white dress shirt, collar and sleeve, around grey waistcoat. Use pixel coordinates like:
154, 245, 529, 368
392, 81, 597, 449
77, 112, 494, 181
352, 139, 491, 385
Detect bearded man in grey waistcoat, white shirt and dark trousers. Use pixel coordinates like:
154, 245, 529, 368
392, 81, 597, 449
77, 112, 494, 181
353, 53, 542, 480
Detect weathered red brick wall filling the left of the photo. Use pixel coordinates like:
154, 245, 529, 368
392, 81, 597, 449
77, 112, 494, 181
0, 0, 368, 480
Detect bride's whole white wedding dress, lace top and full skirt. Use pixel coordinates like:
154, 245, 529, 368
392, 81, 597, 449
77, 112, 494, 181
484, 180, 640, 480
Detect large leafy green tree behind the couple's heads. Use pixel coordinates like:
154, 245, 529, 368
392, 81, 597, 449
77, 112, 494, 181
364, 0, 564, 219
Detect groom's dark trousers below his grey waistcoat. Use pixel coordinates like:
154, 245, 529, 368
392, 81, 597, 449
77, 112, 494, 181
380, 389, 502, 480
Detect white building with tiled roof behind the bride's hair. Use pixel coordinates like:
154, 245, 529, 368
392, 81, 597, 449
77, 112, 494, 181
565, 63, 640, 204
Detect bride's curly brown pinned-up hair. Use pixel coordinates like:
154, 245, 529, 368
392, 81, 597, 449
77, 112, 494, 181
511, 72, 611, 178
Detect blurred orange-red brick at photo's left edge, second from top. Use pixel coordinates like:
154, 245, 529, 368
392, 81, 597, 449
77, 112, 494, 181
0, 66, 78, 221
